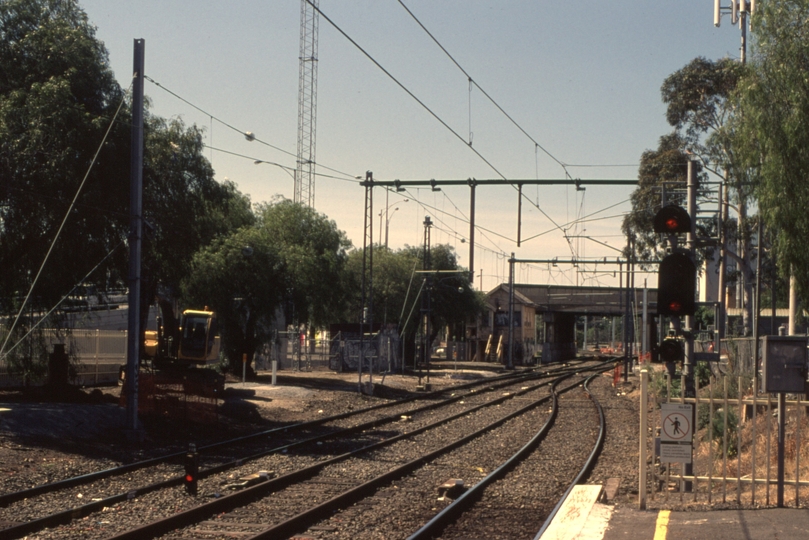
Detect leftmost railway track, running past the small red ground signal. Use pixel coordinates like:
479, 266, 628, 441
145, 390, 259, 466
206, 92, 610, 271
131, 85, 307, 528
0, 360, 596, 538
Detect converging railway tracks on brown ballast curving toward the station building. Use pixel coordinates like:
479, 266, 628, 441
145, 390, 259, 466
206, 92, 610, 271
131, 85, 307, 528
0, 359, 615, 539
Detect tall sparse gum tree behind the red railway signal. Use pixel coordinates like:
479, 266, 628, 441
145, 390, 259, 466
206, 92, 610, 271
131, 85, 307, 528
623, 57, 755, 334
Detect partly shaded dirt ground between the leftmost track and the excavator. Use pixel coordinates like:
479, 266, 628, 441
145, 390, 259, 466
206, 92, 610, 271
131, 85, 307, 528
0, 365, 500, 464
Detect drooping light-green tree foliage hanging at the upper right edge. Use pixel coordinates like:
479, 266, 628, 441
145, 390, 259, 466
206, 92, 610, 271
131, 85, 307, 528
736, 0, 809, 299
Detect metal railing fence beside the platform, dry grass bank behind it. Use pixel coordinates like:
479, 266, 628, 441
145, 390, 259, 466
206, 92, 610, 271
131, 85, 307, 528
640, 371, 809, 508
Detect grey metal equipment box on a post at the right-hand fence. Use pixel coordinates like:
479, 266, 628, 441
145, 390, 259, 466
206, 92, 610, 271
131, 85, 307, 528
761, 336, 807, 394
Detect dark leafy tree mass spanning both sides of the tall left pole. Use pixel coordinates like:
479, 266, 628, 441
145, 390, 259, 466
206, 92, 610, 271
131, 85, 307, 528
0, 0, 254, 380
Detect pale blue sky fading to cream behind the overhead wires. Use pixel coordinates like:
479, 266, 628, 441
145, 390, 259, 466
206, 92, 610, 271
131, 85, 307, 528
79, 0, 740, 291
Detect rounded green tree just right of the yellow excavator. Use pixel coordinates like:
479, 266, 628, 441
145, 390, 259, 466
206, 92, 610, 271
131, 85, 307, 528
182, 198, 350, 372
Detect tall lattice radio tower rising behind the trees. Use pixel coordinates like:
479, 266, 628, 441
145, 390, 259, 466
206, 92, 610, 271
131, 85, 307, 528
293, 0, 319, 208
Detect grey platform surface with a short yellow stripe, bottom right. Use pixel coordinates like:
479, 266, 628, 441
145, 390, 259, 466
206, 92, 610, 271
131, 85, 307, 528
604, 507, 809, 540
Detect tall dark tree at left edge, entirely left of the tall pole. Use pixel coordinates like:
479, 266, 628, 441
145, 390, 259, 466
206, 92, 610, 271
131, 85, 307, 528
0, 0, 129, 313
